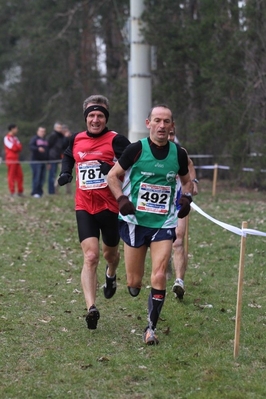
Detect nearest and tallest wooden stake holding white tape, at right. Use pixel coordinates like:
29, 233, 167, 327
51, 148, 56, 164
234, 222, 248, 358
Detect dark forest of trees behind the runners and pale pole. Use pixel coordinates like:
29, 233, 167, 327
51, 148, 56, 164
0, 0, 266, 188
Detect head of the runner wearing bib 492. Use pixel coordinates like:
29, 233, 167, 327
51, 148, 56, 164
146, 107, 174, 146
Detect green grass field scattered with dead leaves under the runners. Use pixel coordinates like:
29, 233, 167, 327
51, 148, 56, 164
0, 165, 266, 399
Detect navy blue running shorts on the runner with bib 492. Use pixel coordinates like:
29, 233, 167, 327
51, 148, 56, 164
118, 220, 176, 248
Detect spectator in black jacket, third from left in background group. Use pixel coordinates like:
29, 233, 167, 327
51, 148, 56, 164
48, 122, 65, 194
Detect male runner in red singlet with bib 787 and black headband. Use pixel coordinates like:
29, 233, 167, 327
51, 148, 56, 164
58, 95, 130, 330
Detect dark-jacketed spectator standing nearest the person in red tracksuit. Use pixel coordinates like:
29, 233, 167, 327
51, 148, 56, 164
29, 126, 48, 198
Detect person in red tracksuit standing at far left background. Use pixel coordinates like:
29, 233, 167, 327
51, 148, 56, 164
4, 124, 23, 197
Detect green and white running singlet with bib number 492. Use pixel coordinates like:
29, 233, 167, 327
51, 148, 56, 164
119, 138, 179, 228
